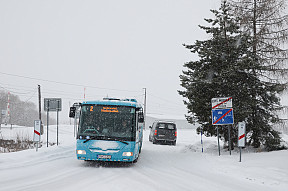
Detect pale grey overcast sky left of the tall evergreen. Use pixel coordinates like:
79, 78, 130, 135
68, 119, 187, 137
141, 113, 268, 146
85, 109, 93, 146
0, 0, 286, 120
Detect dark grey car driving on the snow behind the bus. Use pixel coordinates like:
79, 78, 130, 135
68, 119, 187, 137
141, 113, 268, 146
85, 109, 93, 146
149, 121, 177, 145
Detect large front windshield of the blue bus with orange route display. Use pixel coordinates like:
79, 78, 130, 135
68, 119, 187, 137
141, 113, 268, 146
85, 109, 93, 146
77, 105, 136, 141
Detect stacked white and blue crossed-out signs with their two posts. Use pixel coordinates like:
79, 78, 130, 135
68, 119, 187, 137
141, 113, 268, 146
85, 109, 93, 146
211, 97, 234, 156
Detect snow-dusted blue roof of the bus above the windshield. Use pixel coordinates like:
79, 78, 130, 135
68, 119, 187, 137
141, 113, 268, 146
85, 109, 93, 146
82, 99, 141, 108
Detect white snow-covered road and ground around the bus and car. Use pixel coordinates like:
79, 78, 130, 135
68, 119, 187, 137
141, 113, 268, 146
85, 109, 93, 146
0, 125, 288, 191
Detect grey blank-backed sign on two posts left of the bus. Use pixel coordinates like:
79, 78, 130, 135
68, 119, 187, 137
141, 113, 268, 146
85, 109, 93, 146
44, 98, 62, 147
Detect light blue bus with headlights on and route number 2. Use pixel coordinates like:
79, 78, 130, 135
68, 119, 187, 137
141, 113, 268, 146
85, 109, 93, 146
69, 98, 144, 162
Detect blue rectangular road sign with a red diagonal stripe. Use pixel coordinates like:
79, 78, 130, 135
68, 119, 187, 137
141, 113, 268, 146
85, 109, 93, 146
212, 108, 234, 125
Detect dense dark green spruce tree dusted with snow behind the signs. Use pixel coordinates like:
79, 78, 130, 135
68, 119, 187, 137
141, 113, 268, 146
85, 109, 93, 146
179, 1, 283, 150
